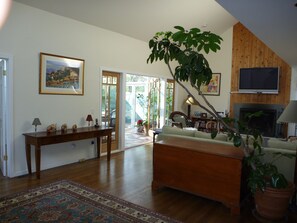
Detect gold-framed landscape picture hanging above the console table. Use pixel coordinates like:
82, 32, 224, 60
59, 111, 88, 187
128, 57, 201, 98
39, 53, 85, 95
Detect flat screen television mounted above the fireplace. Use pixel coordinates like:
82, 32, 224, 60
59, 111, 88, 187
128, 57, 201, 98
238, 67, 279, 94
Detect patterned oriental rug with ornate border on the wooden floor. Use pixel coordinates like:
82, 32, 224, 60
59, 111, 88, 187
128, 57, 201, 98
0, 180, 178, 223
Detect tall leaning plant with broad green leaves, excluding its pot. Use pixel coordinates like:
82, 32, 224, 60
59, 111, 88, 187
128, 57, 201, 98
147, 26, 293, 218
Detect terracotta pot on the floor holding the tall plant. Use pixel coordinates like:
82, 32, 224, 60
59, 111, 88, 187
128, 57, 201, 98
254, 183, 295, 220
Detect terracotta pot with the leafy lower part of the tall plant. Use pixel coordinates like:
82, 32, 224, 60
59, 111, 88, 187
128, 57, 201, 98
228, 112, 295, 220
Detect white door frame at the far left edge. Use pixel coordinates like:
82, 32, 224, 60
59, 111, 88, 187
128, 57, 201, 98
0, 53, 14, 177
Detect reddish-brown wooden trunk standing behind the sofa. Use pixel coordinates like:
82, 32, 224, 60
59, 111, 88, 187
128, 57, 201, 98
152, 137, 245, 214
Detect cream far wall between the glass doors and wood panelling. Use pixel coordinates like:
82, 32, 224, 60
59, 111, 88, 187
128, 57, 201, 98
176, 27, 233, 115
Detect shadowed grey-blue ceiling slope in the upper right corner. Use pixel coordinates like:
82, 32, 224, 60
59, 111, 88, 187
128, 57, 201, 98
217, 0, 297, 66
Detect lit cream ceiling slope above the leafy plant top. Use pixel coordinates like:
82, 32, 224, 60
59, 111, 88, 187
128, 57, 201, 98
14, 0, 237, 42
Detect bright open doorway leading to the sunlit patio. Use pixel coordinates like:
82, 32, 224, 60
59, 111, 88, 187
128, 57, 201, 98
125, 74, 175, 148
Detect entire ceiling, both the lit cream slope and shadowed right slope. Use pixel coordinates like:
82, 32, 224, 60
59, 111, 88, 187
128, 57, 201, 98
14, 0, 297, 65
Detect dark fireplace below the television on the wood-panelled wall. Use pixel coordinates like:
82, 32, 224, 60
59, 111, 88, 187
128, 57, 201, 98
234, 104, 284, 137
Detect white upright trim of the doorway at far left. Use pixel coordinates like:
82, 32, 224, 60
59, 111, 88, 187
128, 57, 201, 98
0, 53, 15, 177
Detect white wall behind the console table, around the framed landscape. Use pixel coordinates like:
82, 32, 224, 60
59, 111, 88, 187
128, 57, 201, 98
0, 1, 168, 176
